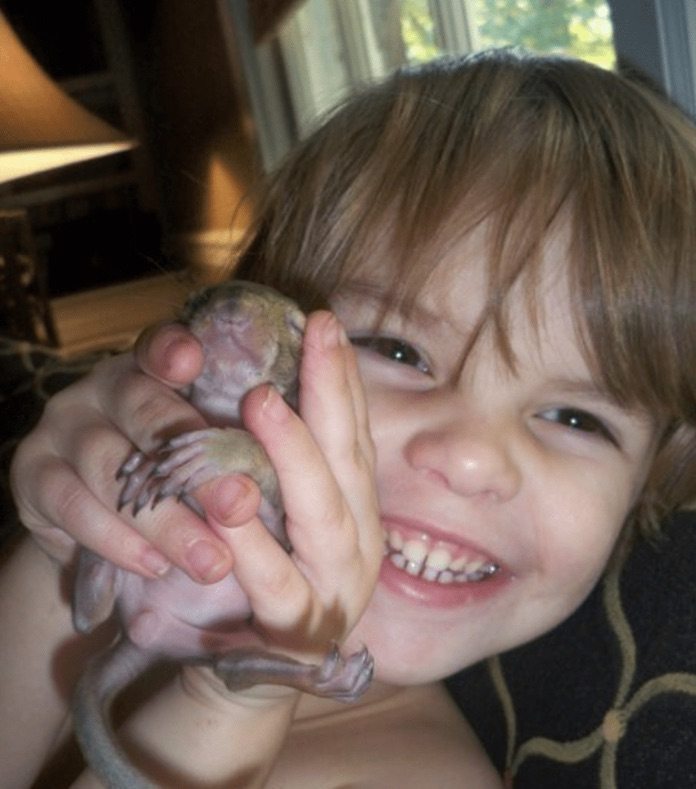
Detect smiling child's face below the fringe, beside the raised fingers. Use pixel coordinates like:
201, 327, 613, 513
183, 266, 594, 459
334, 226, 656, 683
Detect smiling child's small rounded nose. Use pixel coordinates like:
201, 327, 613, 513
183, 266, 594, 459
406, 424, 521, 501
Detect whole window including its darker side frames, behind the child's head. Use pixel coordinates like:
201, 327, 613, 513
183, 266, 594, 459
226, 0, 696, 167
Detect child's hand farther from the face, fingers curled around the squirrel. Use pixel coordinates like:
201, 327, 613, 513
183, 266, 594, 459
11, 325, 247, 581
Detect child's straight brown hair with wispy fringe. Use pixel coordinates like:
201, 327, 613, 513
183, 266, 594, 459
238, 50, 696, 527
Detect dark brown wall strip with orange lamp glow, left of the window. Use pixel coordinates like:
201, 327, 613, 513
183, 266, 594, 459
124, 0, 258, 280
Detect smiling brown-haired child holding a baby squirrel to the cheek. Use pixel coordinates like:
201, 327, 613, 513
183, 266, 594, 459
0, 51, 696, 788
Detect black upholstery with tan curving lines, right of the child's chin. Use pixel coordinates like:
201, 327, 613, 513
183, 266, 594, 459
449, 512, 696, 789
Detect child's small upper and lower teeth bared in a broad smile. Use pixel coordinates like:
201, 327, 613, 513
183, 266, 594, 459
385, 529, 500, 584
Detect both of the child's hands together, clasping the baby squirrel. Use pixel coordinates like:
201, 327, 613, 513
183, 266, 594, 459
13, 313, 381, 640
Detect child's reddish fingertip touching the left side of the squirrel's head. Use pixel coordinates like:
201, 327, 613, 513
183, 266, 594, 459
134, 322, 203, 387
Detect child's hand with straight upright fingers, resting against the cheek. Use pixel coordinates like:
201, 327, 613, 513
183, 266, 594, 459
209, 312, 383, 653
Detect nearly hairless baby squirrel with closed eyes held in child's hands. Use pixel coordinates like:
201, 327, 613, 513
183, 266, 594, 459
73, 280, 372, 789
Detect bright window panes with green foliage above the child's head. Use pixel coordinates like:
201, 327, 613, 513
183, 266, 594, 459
279, 0, 614, 136
